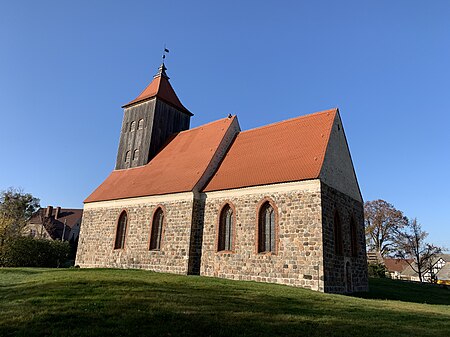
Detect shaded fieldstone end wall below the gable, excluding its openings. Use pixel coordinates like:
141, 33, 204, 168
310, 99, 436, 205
321, 183, 368, 293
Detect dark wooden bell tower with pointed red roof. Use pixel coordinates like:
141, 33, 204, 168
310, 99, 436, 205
116, 62, 193, 170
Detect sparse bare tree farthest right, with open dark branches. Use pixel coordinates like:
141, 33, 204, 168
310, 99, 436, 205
396, 218, 442, 282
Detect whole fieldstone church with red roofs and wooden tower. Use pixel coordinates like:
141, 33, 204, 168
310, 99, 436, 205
76, 63, 368, 293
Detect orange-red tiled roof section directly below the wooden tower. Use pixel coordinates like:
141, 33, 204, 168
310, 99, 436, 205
84, 117, 236, 203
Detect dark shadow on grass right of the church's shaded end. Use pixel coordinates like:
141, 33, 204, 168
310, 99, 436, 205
351, 278, 450, 305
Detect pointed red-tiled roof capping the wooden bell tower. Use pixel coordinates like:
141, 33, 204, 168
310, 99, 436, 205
122, 63, 192, 116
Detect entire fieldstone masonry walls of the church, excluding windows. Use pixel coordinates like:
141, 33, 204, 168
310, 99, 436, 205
76, 179, 368, 293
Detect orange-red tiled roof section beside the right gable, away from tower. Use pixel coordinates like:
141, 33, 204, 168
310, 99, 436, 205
204, 109, 337, 191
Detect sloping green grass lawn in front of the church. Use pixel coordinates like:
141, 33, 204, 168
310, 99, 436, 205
0, 268, 450, 337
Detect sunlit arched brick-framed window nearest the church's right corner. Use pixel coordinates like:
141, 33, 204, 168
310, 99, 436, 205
258, 201, 276, 253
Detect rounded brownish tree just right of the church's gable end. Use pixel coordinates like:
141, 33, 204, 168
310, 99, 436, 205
364, 199, 408, 256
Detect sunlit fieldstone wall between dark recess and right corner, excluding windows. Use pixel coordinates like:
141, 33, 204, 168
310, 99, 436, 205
200, 180, 324, 291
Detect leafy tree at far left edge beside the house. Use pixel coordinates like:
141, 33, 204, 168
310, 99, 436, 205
0, 187, 40, 247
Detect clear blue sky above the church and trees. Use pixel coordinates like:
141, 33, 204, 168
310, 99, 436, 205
0, 0, 450, 248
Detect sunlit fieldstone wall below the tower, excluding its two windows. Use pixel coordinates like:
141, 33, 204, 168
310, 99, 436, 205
76, 193, 194, 274
